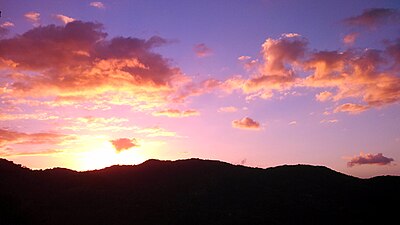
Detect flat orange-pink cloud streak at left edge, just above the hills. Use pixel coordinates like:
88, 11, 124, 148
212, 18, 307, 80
0, 129, 73, 147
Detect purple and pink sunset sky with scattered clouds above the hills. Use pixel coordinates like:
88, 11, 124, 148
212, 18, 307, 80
0, 0, 400, 177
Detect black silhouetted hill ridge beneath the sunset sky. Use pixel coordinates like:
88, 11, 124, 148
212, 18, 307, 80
0, 159, 400, 225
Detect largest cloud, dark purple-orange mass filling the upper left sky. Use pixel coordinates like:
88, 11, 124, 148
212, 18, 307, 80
0, 21, 188, 108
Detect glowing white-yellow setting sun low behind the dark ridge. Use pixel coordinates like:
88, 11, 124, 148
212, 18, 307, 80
77, 140, 146, 171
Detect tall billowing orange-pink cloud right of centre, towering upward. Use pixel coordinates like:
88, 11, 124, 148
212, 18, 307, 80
219, 34, 308, 100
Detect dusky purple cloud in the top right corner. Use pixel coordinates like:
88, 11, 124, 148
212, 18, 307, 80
344, 8, 400, 28
